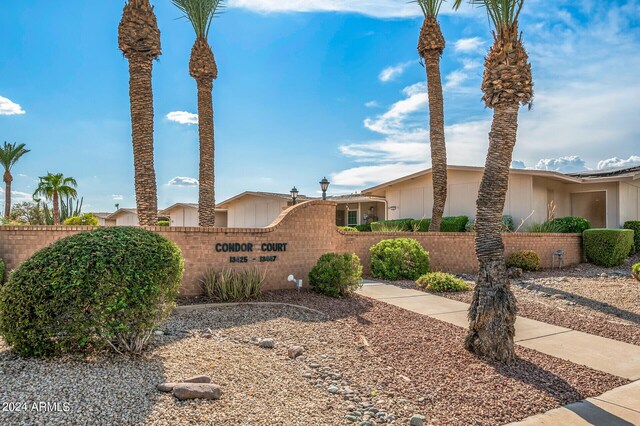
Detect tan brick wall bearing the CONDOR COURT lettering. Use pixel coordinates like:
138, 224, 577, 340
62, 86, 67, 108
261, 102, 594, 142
0, 201, 582, 295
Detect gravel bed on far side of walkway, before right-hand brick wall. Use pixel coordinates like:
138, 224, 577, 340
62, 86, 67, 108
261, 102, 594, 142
392, 255, 640, 345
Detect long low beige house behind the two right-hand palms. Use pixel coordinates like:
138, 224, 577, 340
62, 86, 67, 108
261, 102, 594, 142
362, 166, 640, 227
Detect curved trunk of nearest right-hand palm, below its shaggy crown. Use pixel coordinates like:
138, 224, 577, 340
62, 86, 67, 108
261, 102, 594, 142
465, 101, 519, 363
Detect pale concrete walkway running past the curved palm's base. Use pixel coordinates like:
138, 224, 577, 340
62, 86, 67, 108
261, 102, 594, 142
358, 281, 640, 426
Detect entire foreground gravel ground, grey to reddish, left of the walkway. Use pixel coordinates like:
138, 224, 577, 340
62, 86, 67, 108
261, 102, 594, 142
0, 292, 627, 425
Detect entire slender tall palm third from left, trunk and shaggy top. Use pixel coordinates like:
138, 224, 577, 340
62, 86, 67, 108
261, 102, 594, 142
417, 0, 447, 232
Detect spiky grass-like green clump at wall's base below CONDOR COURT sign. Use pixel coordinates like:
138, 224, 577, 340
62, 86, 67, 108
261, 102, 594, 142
200, 268, 265, 302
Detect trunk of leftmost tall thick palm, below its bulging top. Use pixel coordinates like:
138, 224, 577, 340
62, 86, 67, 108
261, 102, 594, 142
128, 52, 158, 226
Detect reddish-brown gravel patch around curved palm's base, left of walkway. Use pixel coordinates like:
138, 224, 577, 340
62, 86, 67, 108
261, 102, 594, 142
263, 291, 628, 425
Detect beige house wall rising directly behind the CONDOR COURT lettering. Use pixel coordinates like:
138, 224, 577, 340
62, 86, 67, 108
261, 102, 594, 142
225, 195, 284, 228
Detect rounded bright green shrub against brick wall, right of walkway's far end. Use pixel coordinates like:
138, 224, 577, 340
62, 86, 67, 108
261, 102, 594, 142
370, 238, 429, 280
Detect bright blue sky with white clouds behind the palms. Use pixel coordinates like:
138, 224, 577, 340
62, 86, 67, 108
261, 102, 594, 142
0, 0, 640, 211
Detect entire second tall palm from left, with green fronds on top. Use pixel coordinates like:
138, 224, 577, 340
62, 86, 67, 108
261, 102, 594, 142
171, 0, 223, 226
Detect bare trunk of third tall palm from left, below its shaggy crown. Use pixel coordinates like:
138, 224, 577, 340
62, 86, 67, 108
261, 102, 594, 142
425, 50, 447, 232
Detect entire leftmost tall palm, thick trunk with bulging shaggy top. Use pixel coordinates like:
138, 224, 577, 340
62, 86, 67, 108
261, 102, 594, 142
118, 0, 162, 226
